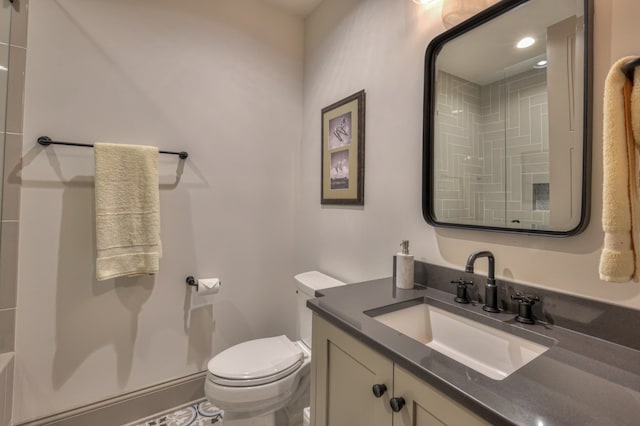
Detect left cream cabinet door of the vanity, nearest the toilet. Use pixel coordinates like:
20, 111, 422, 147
311, 314, 393, 426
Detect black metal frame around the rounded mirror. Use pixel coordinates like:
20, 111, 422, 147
422, 0, 593, 237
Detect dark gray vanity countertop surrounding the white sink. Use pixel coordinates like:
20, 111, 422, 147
307, 278, 640, 426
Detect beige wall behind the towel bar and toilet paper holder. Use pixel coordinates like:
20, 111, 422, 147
14, 0, 303, 422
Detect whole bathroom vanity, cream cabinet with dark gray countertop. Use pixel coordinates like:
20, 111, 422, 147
307, 267, 640, 426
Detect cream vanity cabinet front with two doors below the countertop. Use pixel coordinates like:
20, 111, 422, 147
311, 314, 490, 426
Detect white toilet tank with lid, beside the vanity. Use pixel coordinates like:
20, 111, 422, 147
295, 271, 345, 347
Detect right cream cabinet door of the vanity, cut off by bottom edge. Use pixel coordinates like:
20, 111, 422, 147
393, 365, 490, 426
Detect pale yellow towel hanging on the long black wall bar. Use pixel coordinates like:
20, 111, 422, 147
94, 143, 162, 281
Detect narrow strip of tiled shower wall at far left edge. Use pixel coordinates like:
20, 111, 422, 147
0, 0, 28, 426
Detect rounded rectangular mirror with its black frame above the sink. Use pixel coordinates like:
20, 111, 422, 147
422, 0, 593, 236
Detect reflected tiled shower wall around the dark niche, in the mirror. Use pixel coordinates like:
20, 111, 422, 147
478, 69, 549, 227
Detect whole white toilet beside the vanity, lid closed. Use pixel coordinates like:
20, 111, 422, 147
204, 271, 344, 426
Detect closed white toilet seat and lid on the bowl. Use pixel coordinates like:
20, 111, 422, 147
207, 335, 304, 387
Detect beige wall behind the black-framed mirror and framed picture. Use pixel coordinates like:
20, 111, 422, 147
296, 0, 640, 309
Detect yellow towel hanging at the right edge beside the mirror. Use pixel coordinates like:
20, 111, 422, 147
600, 57, 640, 282
